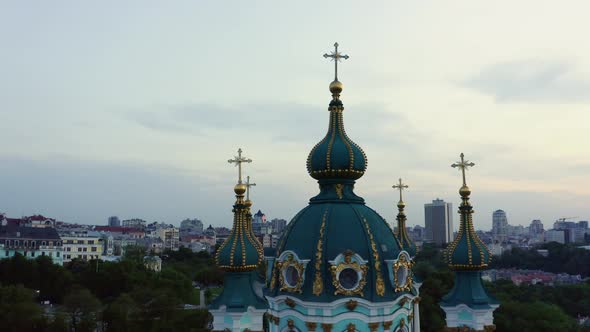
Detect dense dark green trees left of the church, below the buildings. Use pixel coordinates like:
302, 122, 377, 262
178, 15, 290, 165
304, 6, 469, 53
0, 248, 223, 332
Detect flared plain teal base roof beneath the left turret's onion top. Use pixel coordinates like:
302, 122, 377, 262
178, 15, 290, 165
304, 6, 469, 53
209, 271, 268, 312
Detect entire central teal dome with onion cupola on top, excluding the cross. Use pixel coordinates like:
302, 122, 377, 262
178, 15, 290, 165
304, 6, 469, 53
268, 76, 415, 303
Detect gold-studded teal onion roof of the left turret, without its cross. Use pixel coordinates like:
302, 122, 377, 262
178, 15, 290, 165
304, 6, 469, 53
215, 184, 263, 271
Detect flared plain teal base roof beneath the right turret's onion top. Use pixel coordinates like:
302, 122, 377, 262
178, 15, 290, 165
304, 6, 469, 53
441, 271, 499, 309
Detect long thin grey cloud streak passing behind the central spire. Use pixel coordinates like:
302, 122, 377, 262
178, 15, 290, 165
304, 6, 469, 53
126, 103, 409, 144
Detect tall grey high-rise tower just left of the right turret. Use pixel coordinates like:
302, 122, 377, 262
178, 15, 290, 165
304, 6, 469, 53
424, 198, 454, 245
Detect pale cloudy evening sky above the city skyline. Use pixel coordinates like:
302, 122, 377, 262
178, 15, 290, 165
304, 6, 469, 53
0, 0, 590, 229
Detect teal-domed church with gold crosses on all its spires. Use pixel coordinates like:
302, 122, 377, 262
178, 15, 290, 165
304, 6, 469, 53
209, 43, 498, 332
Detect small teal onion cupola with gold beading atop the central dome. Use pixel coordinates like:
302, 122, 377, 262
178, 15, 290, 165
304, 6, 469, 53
307, 81, 367, 179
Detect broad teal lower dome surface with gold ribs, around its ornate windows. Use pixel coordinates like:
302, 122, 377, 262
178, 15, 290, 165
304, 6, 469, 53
270, 192, 408, 302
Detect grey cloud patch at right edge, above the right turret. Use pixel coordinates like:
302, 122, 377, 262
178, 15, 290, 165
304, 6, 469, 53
462, 60, 590, 103
